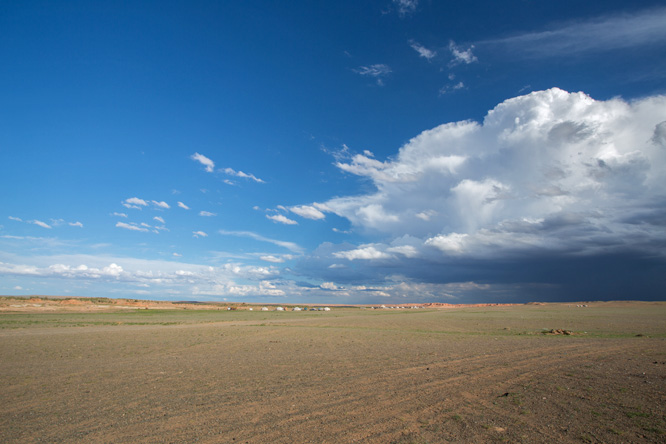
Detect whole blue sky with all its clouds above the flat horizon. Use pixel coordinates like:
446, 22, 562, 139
0, 0, 666, 303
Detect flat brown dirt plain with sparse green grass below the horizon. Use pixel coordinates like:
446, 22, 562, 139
0, 302, 666, 444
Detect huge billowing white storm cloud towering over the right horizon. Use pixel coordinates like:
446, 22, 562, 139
300, 88, 666, 298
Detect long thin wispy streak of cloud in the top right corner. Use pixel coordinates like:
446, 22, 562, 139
477, 8, 666, 58
